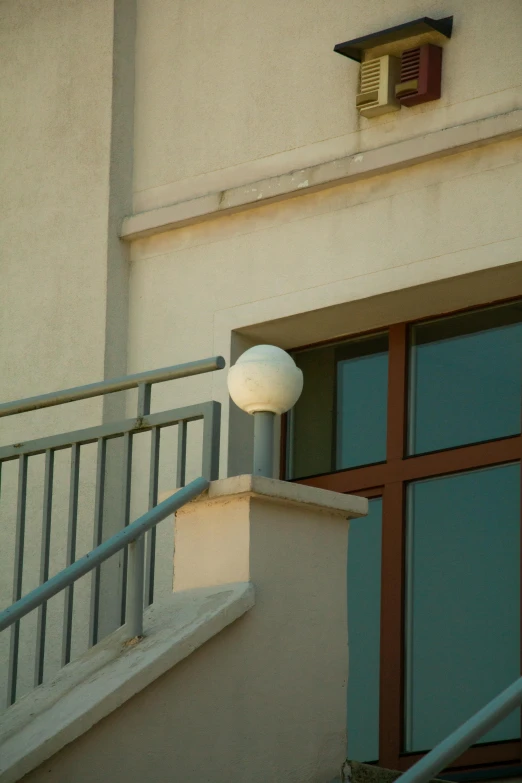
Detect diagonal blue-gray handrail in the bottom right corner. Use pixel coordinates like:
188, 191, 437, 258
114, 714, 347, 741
396, 677, 522, 783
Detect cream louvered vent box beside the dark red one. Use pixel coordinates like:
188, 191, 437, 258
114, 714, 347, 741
356, 54, 401, 117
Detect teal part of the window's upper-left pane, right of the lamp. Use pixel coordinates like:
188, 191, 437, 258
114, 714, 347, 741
335, 334, 388, 470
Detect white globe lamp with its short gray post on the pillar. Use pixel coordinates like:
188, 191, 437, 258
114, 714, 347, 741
228, 345, 303, 478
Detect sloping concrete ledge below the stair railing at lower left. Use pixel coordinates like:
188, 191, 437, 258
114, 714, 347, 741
0, 583, 254, 783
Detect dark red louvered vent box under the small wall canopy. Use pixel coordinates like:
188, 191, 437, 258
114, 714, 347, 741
395, 44, 442, 106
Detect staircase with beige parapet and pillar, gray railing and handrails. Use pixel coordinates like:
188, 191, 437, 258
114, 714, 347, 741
0, 357, 522, 783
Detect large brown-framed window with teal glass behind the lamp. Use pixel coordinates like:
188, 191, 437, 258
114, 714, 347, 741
286, 300, 522, 769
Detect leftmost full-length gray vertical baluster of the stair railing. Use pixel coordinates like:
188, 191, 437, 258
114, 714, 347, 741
7, 454, 28, 706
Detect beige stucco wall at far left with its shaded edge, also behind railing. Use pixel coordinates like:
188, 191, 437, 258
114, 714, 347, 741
0, 0, 134, 702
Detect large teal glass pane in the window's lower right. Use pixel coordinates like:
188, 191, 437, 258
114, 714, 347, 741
405, 464, 520, 751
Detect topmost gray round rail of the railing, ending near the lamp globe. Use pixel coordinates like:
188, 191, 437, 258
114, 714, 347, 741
0, 356, 225, 417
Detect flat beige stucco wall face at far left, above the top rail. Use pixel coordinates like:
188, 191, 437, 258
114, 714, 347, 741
0, 0, 121, 428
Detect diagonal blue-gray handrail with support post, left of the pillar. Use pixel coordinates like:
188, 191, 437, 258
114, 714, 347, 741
0, 477, 209, 639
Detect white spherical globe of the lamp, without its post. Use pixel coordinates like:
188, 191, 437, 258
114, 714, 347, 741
228, 345, 303, 414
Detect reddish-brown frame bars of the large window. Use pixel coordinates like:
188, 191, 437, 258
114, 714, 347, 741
281, 306, 522, 771
